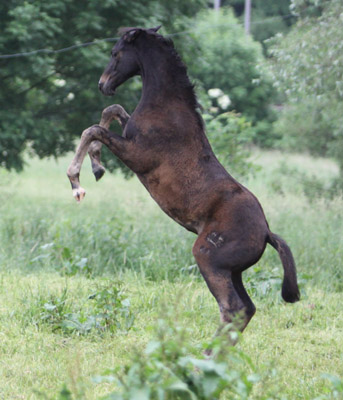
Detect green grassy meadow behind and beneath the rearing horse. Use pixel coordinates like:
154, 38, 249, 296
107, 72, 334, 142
0, 151, 343, 400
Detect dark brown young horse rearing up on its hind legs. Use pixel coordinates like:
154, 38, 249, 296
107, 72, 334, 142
68, 28, 300, 331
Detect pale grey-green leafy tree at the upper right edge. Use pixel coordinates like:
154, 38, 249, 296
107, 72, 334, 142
270, 0, 343, 183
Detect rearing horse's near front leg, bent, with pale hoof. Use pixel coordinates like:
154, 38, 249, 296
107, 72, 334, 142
67, 125, 130, 202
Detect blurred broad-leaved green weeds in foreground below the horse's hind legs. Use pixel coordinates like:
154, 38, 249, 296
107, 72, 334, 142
95, 316, 261, 400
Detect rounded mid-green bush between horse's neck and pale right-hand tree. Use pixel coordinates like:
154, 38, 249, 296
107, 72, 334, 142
184, 9, 273, 122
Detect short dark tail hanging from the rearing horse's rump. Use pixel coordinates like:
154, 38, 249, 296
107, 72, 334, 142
267, 232, 300, 303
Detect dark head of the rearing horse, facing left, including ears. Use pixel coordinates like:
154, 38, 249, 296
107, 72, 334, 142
99, 26, 160, 96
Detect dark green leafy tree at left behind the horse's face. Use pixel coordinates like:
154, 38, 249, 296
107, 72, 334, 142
0, 0, 207, 170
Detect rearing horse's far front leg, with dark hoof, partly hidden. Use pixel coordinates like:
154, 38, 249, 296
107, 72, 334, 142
88, 104, 130, 181
